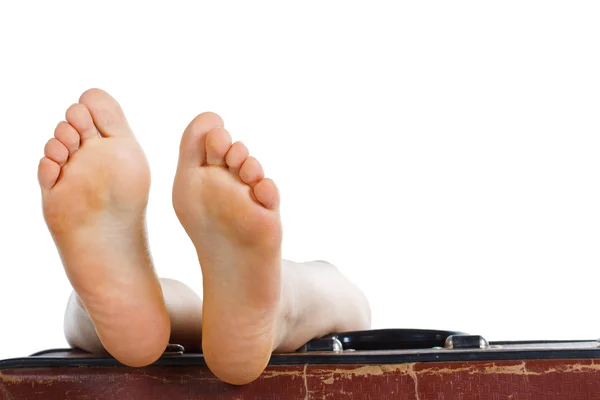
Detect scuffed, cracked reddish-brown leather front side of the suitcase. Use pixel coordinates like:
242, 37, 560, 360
0, 359, 600, 400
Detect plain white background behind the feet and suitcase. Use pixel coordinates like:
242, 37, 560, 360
0, 1, 600, 358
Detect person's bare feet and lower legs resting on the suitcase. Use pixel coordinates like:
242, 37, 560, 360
38, 89, 370, 384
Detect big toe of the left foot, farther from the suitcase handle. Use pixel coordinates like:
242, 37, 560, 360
79, 89, 132, 137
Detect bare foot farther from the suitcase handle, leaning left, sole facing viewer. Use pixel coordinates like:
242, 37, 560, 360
38, 89, 169, 366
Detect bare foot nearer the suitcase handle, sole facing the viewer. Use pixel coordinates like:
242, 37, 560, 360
173, 113, 282, 384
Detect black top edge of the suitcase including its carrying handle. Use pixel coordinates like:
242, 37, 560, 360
0, 329, 600, 370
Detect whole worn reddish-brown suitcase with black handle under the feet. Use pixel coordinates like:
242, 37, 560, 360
0, 330, 600, 400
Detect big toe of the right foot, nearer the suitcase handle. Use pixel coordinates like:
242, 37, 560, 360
179, 112, 224, 167
